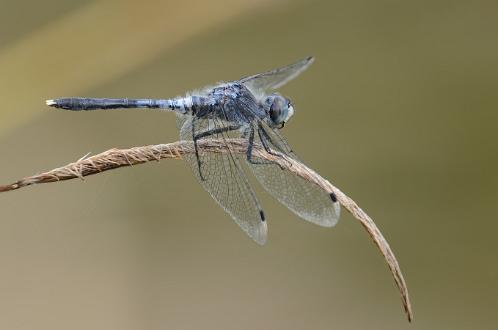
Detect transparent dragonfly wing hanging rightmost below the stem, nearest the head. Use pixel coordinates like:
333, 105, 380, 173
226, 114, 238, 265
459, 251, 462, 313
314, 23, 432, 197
247, 122, 340, 227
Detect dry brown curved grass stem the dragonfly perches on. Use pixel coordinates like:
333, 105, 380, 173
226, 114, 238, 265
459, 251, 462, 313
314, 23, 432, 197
0, 139, 413, 321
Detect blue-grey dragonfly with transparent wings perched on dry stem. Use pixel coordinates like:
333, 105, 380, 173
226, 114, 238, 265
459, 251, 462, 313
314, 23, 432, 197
46, 57, 340, 245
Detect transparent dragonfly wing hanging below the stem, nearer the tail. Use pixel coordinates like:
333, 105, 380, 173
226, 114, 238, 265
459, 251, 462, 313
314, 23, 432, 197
177, 114, 267, 245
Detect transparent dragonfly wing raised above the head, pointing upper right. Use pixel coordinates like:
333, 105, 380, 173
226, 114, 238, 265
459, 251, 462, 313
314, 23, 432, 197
239, 56, 314, 92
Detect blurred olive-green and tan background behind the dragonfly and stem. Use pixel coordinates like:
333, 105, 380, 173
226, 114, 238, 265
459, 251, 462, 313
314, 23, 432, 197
0, 0, 498, 330
